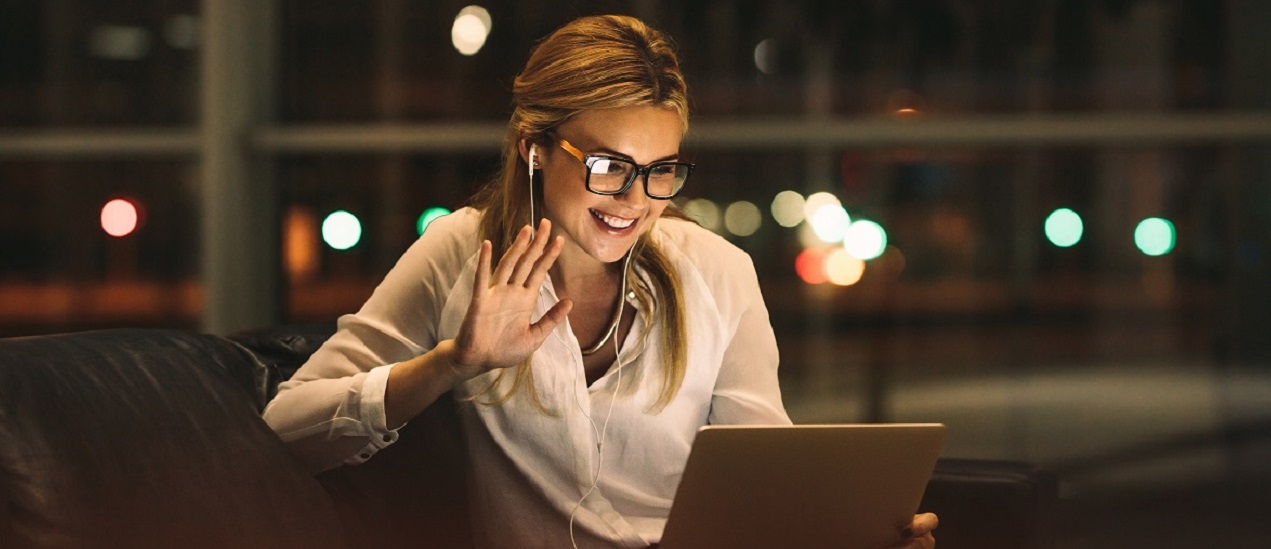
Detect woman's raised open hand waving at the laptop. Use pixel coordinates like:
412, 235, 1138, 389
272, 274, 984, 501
451, 220, 573, 377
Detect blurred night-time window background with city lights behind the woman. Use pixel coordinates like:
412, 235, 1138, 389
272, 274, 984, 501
0, 0, 1271, 548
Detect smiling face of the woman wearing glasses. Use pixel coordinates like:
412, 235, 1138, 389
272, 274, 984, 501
538, 107, 684, 263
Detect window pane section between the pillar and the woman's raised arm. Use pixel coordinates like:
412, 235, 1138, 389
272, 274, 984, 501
277, 153, 498, 322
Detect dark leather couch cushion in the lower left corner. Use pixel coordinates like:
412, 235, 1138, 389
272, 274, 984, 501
0, 330, 344, 548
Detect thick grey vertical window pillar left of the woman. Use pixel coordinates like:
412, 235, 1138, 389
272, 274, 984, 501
200, 0, 281, 333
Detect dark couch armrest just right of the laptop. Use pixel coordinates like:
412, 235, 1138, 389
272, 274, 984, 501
919, 459, 1057, 549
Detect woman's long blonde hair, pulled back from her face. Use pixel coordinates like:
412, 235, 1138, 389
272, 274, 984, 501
472, 15, 689, 412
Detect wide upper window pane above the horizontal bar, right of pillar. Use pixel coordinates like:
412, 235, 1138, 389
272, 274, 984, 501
280, 0, 1250, 122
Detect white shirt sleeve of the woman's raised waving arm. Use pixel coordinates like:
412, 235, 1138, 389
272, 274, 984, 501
264, 209, 477, 470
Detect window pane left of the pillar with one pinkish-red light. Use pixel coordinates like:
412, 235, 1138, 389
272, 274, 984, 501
0, 160, 201, 336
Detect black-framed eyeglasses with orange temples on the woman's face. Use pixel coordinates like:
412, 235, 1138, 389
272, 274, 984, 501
557, 137, 693, 200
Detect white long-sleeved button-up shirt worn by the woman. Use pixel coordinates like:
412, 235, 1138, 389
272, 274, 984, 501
264, 208, 789, 548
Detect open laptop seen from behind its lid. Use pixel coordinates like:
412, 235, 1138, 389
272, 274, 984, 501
660, 423, 946, 549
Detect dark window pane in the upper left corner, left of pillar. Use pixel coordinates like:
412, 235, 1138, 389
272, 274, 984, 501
0, 0, 200, 128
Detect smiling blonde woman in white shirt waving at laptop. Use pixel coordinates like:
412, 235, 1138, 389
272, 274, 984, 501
264, 12, 934, 548
